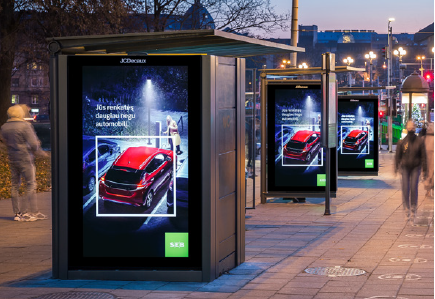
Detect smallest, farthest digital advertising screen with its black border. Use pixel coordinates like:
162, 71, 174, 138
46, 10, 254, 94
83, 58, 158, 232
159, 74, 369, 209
337, 96, 379, 175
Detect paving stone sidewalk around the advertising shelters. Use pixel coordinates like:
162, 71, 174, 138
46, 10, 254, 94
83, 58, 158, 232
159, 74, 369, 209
0, 151, 434, 299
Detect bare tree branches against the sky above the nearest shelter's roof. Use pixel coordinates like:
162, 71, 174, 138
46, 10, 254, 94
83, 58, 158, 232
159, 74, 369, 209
129, 0, 289, 35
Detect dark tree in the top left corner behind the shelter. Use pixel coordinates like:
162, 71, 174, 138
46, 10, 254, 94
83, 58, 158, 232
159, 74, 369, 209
0, 0, 130, 125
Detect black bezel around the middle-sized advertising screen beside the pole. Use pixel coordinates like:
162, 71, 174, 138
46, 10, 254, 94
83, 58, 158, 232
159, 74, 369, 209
267, 80, 337, 195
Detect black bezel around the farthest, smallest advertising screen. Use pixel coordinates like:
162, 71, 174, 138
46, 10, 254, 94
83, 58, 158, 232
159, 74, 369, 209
337, 95, 379, 175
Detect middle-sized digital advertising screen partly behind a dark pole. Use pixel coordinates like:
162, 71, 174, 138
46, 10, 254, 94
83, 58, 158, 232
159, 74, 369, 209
267, 81, 336, 192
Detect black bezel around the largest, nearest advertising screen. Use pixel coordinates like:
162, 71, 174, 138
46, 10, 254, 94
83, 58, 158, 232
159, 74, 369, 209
67, 55, 202, 270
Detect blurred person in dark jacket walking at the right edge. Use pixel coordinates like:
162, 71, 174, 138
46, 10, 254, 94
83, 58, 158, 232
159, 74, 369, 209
394, 120, 427, 223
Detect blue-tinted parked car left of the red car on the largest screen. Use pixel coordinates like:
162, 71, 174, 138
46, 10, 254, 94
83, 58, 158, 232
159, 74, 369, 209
83, 137, 121, 193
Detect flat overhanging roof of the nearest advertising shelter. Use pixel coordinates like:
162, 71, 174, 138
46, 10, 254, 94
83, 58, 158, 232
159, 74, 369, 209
47, 29, 305, 57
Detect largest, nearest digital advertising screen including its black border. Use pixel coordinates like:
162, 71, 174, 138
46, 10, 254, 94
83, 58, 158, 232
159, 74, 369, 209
68, 56, 201, 270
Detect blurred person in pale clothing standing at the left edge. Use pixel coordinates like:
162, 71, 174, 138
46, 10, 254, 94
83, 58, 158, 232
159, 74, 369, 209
1, 105, 47, 221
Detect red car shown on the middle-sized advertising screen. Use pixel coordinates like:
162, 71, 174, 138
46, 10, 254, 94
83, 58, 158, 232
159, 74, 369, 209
283, 130, 320, 162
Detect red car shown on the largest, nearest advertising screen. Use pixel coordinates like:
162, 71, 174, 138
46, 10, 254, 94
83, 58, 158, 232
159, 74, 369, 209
99, 146, 175, 208
